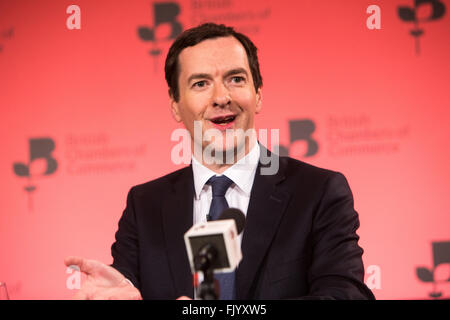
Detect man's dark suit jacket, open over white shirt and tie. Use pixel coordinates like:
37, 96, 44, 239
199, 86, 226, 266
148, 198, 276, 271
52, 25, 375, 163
112, 150, 374, 299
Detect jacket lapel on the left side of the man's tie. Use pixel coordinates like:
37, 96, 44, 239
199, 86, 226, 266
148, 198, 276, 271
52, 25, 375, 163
162, 166, 194, 298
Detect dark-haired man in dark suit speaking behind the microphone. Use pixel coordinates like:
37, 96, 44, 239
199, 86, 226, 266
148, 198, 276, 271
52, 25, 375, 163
65, 24, 373, 299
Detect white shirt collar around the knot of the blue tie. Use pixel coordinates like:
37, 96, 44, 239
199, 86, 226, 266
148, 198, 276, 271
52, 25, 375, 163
192, 143, 260, 199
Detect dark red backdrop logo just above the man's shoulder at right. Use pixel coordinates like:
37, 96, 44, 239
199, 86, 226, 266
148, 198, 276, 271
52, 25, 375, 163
280, 119, 319, 157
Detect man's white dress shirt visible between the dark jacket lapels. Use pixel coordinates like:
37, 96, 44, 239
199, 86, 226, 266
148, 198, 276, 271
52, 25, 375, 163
192, 143, 260, 241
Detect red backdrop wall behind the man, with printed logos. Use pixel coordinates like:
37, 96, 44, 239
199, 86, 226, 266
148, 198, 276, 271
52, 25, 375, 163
0, 0, 450, 299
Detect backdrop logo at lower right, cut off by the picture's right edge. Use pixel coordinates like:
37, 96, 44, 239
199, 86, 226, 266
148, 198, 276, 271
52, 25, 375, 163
416, 241, 450, 299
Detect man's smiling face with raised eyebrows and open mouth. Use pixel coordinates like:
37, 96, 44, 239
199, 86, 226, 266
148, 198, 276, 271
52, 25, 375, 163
171, 37, 261, 159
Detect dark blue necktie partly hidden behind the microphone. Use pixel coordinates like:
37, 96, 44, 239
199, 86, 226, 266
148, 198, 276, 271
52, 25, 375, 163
207, 176, 235, 300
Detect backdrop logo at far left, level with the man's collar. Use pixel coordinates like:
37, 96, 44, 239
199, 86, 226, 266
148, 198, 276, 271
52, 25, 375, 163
13, 138, 58, 210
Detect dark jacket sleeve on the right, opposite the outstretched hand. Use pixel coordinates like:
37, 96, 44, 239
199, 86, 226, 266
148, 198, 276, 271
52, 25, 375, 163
302, 172, 375, 299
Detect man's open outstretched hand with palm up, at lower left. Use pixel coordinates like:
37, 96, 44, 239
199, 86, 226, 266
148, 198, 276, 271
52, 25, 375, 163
64, 257, 142, 300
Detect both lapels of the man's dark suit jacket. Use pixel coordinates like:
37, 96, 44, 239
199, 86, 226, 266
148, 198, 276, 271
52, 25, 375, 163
162, 146, 291, 299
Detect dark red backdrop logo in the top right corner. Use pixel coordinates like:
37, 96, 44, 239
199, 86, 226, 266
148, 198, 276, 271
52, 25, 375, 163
398, 0, 445, 54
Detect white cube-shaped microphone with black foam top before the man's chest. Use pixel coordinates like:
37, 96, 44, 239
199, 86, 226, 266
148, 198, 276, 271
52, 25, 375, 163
184, 208, 245, 274
